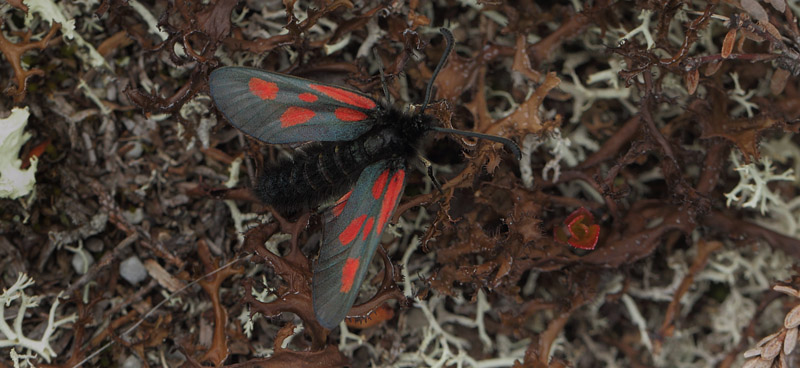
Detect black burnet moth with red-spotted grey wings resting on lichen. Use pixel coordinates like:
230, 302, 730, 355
209, 28, 520, 329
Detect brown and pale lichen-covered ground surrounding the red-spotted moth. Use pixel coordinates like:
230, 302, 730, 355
0, 0, 800, 367
